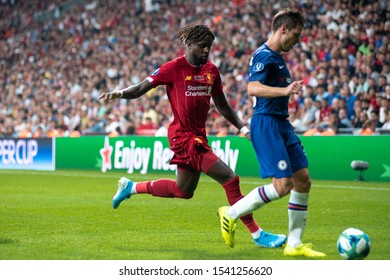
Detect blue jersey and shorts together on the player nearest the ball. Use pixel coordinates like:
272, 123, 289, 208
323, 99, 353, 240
249, 44, 309, 178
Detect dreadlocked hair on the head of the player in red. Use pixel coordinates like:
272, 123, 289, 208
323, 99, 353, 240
176, 24, 215, 46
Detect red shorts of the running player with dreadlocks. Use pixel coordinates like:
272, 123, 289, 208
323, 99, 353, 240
170, 136, 219, 174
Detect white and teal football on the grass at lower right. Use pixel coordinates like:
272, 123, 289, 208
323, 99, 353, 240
337, 228, 371, 260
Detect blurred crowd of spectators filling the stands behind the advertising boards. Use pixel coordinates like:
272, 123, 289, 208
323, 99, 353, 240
0, 0, 390, 137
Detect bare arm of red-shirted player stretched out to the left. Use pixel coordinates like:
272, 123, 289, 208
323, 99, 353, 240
99, 80, 153, 101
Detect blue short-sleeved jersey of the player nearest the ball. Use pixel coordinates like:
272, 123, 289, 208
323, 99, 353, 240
249, 44, 291, 118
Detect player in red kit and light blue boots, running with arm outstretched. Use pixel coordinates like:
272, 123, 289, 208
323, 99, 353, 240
99, 25, 285, 247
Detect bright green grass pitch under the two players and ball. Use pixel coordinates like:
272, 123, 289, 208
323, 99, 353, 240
0, 170, 390, 260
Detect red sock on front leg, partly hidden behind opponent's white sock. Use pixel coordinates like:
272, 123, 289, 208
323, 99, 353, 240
222, 176, 260, 233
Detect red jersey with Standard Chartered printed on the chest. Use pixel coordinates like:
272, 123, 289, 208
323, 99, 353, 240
147, 56, 224, 140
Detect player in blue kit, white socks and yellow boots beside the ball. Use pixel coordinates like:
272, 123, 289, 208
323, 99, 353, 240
218, 9, 326, 258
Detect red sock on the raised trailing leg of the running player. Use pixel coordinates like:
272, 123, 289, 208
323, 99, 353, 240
136, 179, 193, 199
